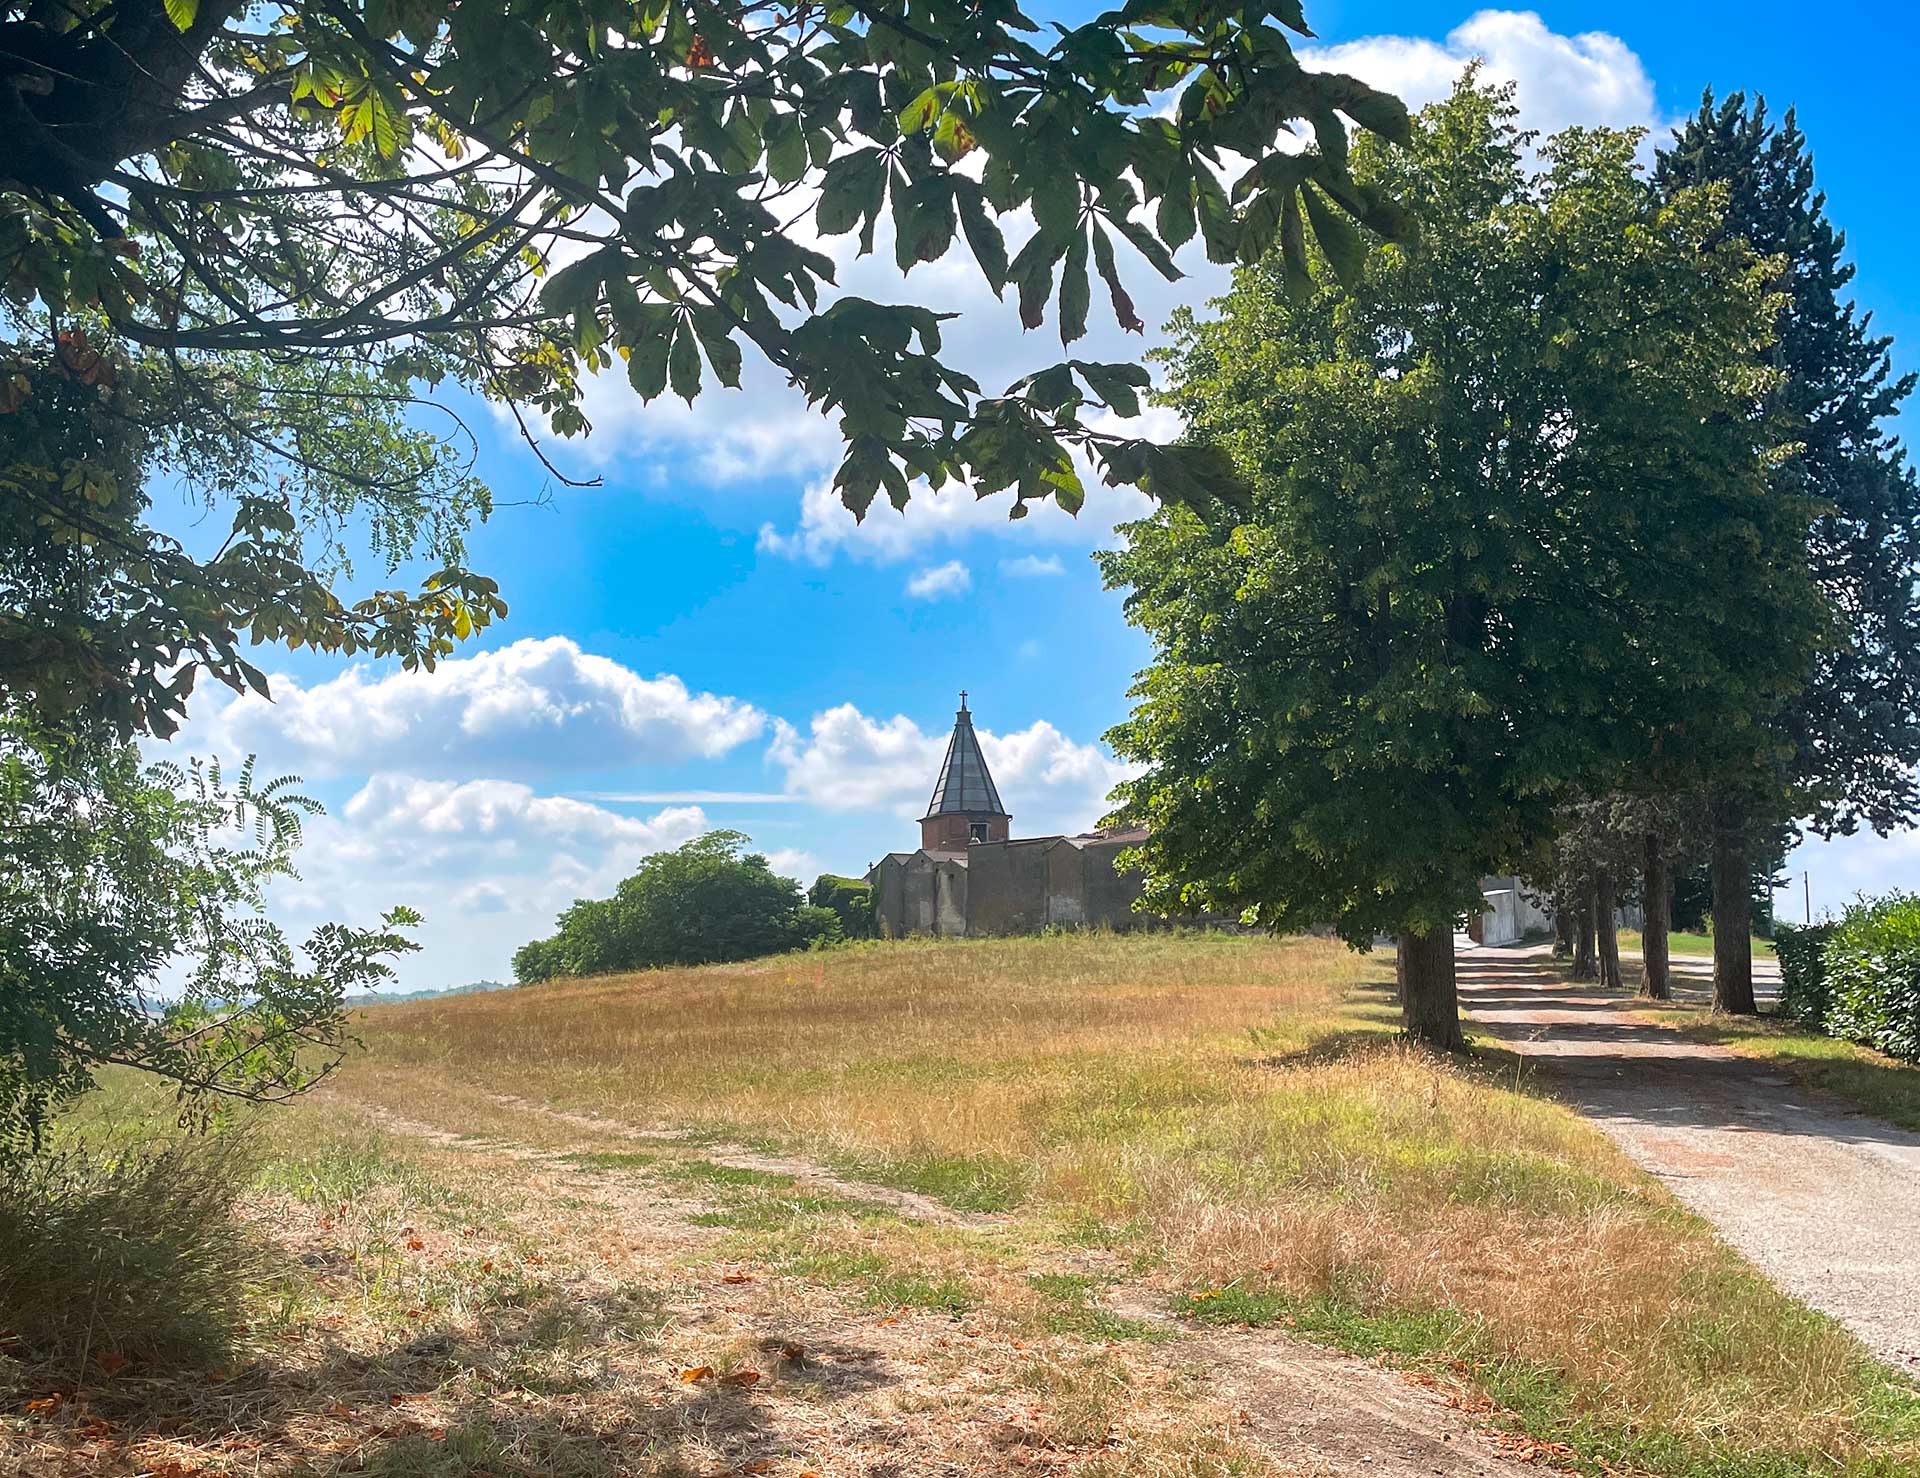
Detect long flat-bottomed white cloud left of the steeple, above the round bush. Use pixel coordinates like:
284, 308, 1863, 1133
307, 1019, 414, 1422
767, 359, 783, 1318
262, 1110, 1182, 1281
186, 637, 766, 775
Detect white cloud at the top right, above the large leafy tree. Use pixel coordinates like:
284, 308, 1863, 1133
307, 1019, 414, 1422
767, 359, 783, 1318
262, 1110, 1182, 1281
1300, 10, 1661, 134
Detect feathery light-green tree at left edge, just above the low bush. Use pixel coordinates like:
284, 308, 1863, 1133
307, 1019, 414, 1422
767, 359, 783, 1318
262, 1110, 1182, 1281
0, 720, 419, 1156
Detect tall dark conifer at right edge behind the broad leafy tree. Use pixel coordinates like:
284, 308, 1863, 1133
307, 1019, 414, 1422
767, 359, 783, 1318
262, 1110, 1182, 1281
1655, 92, 1920, 1012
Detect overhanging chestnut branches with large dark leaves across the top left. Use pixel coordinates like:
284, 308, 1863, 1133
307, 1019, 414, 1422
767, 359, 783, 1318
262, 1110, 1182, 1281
0, 0, 1405, 726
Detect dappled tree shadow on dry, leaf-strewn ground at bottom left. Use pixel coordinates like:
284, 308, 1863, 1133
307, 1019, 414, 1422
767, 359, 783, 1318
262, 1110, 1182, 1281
11, 1286, 893, 1478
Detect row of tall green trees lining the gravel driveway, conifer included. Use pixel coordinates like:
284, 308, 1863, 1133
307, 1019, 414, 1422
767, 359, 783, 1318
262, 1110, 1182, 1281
1102, 73, 1920, 1046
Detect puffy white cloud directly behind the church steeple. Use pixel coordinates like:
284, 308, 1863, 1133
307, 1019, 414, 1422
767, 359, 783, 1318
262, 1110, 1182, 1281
768, 703, 1133, 837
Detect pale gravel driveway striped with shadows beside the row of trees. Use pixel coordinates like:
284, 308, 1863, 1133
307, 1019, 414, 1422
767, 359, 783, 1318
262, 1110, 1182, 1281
1459, 946, 1920, 1374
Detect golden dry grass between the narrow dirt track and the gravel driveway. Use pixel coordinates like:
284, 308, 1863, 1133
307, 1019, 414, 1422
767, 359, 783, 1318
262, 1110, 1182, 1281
344, 937, 1920, 1461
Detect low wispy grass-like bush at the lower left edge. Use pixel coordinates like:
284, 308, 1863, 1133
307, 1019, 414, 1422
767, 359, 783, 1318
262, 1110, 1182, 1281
0, 1136, 265, 1363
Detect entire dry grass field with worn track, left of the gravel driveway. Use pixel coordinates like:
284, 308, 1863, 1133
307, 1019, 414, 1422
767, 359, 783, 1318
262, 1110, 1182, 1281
0, 935, 1920, 1478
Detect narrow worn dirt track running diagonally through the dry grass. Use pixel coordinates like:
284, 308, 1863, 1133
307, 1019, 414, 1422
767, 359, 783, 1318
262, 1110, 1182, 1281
376, 1094, 1565, 1478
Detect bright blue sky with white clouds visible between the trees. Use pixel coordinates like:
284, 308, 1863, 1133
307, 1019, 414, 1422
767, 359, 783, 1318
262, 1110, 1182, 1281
157, 11, 1920, 989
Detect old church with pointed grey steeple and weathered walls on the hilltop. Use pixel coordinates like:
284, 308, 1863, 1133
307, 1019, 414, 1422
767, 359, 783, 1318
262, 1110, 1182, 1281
866, 691, 1165, 939
